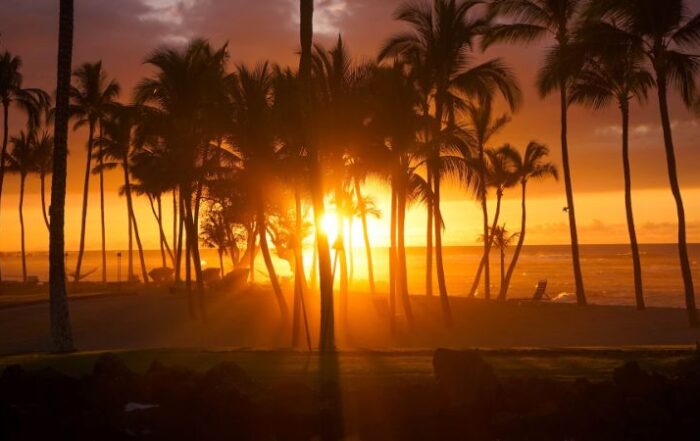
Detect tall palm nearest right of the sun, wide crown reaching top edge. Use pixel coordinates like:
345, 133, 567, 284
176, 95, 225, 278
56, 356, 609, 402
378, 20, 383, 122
379, 0, 521, 326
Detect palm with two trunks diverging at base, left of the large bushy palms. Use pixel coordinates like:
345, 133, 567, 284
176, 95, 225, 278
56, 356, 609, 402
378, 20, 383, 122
96, 105, 149, 283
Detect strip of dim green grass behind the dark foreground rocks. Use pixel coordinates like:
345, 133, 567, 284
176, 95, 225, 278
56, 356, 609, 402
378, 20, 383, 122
0, 348, 693, 383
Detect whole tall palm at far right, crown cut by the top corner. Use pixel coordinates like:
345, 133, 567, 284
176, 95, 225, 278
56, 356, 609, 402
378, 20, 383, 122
587, 0, 700, 327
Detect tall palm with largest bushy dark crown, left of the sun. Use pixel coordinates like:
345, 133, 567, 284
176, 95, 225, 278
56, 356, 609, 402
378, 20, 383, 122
134, 40, 231, 317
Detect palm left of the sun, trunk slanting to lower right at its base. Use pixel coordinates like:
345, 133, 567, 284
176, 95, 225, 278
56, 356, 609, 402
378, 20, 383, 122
232, 63, 289, 320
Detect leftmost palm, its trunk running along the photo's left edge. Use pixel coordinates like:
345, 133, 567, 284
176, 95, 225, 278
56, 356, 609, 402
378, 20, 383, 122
0, 51, 50, 278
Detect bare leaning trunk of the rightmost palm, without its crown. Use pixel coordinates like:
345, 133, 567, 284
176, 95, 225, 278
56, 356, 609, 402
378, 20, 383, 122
657, 72, 700, 328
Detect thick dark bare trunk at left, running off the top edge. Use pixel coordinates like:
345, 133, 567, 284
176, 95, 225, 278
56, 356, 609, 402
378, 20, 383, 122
48, 0, 75, 352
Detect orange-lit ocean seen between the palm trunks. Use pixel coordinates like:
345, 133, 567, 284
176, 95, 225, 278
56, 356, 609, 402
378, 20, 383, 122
0, 244, 700, 307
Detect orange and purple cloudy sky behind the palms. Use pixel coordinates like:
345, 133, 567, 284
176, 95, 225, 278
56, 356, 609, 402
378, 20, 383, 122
0, 0, 700, 250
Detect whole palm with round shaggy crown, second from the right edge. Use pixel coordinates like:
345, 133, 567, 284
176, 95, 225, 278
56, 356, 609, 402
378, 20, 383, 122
571, 27, 654, 310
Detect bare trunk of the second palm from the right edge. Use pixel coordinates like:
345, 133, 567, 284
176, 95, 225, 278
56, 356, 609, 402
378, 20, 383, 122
620, 101, 646, 311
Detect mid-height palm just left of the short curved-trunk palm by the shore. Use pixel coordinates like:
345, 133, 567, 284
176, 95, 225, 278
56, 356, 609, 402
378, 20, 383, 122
466, 99, 511, 300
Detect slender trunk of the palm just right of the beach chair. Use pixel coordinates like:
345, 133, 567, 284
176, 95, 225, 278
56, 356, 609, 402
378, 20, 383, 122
559, 86, 587, 306
